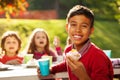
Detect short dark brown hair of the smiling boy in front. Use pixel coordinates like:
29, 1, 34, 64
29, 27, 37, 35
66, 5, 94, 27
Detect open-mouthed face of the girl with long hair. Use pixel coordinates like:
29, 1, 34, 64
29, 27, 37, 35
34, 32, 47, 48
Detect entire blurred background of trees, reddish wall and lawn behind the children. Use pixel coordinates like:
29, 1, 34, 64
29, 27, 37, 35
0, 0, 120, 58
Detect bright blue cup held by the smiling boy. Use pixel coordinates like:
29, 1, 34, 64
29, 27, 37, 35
38, 58, 50, 76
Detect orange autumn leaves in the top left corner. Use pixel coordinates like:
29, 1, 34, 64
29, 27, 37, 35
0, 0, 28, 18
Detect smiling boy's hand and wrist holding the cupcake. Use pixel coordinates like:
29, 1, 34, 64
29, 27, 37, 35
66, 56, 90, 80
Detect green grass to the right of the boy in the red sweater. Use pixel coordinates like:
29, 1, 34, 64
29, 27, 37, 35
91, 21, 120, 57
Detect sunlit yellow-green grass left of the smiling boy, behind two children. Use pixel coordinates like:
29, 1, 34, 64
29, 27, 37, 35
0, 19, 67, 50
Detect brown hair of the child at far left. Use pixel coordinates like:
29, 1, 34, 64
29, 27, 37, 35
1, 31, 21, 54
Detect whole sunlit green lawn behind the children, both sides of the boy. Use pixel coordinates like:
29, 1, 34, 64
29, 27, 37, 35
0, 19, 120, 57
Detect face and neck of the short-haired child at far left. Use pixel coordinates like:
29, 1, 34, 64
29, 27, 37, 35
4, 36, 19, 55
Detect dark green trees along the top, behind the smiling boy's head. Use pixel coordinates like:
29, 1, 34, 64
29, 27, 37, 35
28, 0, 120, 20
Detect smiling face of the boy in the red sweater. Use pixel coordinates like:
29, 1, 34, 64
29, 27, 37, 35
66, 15, 93, 47
